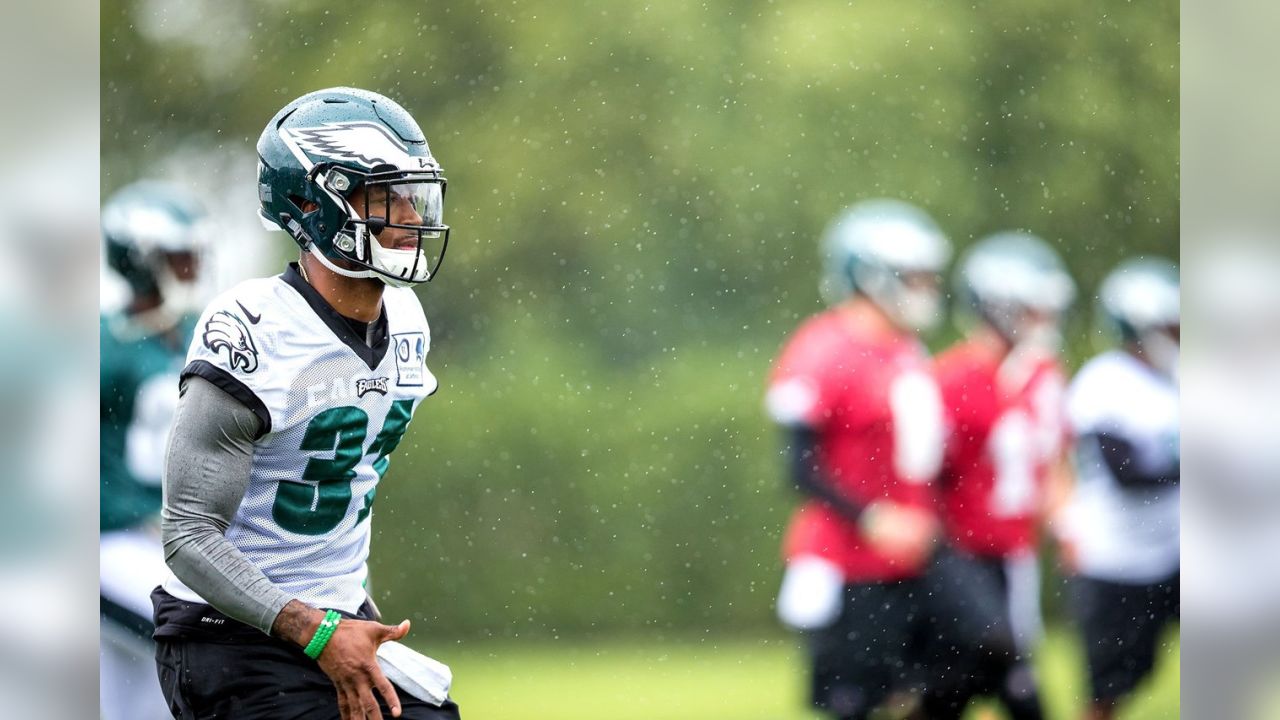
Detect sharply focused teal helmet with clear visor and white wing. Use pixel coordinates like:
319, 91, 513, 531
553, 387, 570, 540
257, 87, 449, 287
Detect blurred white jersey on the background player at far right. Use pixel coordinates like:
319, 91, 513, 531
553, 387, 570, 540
1066, 350, 1179, 583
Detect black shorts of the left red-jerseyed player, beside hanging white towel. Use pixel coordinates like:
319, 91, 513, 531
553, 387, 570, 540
809, 579, 922, 717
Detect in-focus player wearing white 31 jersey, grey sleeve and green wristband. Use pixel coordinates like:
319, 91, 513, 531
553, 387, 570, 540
152, 87, 458, 720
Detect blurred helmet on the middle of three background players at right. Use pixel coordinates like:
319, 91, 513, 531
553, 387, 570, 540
955, 231, 1075, 350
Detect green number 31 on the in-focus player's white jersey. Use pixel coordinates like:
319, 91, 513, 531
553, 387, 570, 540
271, 400, 413, 536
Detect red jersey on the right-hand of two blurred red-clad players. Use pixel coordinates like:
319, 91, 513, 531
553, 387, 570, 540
934, 341, 1066, 557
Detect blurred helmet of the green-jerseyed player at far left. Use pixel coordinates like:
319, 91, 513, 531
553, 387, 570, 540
102, 181, 209, 325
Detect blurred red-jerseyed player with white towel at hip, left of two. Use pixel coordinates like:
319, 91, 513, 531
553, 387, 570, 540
767, 200, 950, 719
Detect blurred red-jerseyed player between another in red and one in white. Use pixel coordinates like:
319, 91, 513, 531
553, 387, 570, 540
925, 232, 1075, 719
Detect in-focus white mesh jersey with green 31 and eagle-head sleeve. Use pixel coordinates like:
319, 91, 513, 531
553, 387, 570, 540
164, 265, 436, 612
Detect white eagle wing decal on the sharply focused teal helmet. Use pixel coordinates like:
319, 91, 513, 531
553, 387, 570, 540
280, 120, 435, 170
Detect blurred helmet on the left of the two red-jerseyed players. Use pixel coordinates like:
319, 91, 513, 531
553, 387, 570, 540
822, 200, 951, 331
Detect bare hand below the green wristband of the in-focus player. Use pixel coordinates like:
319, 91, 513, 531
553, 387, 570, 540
319, 620, 408, 720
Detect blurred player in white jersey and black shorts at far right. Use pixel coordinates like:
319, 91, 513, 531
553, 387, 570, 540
1061, 259, 1180, 719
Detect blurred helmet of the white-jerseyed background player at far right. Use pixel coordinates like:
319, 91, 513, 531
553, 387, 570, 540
1098, 258, 1181, 378
